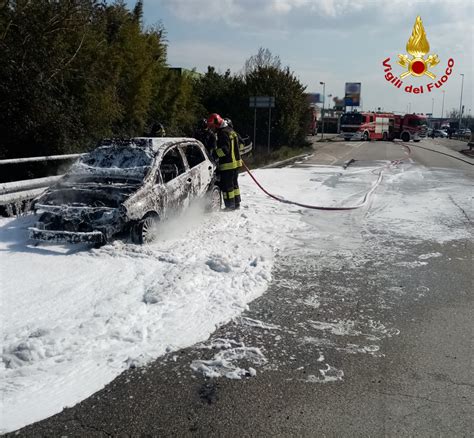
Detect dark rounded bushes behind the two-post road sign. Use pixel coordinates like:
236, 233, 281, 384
198, 48, 309, 151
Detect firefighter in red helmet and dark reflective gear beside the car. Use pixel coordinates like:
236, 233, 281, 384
207, 113, 242, 210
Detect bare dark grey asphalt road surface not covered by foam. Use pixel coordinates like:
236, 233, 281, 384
10, 136, 474, 437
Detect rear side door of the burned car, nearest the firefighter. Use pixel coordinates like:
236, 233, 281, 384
181, 143, 214, 198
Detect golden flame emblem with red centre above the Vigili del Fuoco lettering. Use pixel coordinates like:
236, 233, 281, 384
397, 15, 439, 79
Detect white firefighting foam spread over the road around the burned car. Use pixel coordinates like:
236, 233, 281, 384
0, 164, 472, 432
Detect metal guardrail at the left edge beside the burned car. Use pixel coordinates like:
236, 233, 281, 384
0, 154, 83, 216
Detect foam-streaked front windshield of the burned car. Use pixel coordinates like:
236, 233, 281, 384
70, 145, 153, 179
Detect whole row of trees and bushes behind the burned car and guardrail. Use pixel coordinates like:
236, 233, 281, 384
0, 4, 307, 166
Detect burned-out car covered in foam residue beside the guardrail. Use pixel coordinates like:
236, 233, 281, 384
29, 138, 221, 246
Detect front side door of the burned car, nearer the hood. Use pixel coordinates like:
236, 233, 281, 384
159, 146, 192, 216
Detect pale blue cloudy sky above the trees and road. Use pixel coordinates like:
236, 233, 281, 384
127, 0, 474, 117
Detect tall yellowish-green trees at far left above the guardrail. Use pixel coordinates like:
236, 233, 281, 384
0, 0, 168, 156
